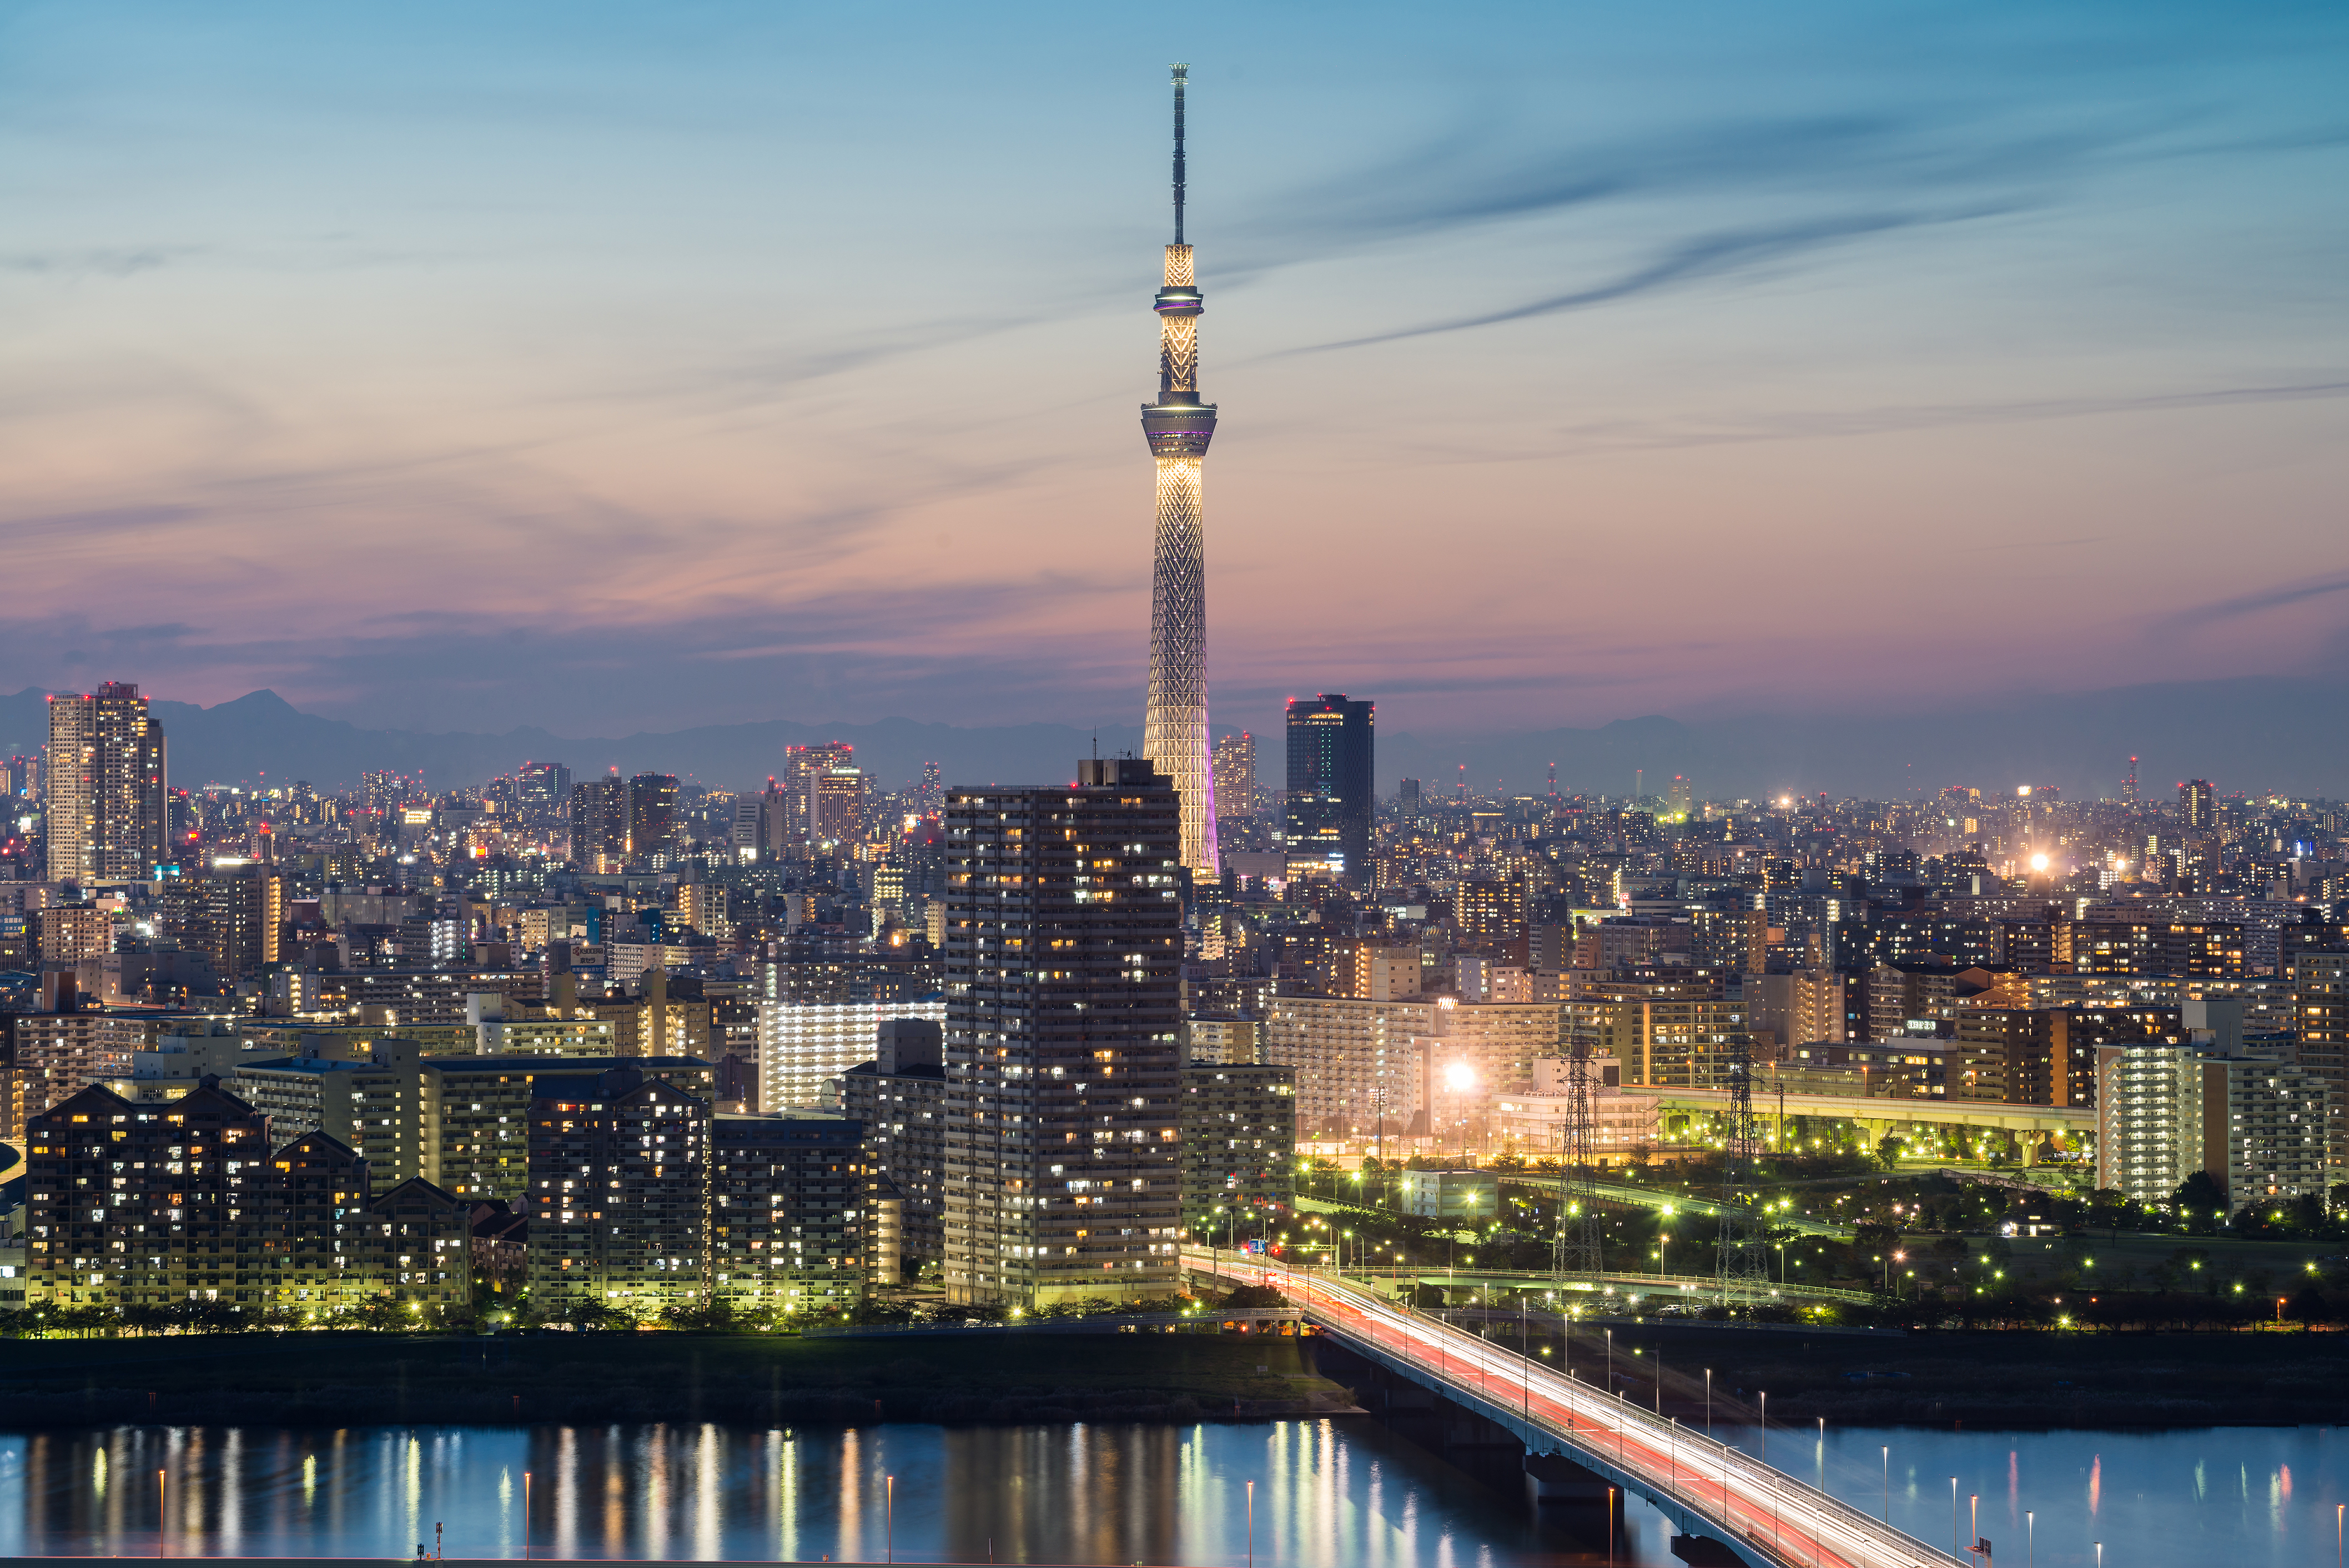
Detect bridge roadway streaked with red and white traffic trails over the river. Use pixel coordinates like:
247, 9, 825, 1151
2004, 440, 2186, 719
1184, 1248, 1966, 1568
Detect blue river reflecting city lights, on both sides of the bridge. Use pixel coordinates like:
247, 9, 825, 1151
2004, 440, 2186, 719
0, 1418, 2349, 1568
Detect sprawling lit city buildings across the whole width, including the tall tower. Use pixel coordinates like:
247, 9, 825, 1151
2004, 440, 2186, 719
0, 86, 2349, 1328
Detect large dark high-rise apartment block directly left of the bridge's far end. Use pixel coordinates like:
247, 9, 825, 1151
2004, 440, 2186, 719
944, 757, 1181, 1307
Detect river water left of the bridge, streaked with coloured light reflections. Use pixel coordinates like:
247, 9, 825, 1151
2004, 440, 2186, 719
0, 1420, 1675, 1568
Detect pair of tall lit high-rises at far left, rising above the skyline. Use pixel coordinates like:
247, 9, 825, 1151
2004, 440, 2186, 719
42, 682, 169, 884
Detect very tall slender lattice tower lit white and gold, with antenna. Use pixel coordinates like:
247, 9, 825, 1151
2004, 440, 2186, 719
1141, 66, 1217, 877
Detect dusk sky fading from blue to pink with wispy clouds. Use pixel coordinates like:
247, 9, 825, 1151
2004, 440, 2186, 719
0, 2, 2349, 733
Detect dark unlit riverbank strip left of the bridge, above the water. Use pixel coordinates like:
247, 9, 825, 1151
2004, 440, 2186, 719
0, 1328, 1349, 1427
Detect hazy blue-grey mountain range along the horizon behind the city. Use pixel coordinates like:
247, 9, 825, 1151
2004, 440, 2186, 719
0, 680, 2349, 800
